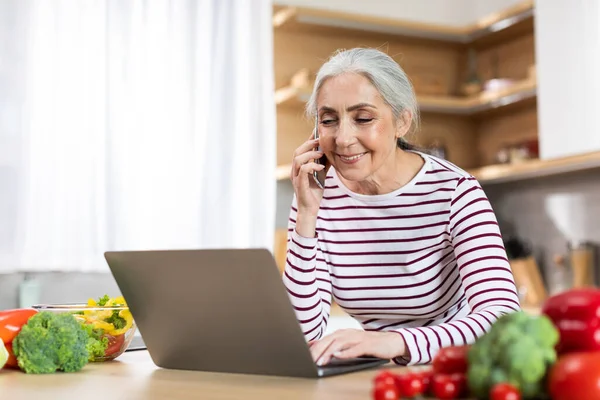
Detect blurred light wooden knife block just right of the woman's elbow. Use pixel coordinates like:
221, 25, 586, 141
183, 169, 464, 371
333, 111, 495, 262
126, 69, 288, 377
510, 257, 548, 307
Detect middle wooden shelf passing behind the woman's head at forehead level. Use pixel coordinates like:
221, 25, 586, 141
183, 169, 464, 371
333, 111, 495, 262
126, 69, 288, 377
275, 69, 537, 115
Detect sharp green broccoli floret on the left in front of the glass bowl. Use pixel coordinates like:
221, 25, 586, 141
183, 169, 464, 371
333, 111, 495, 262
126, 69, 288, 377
13, 311, 89, 374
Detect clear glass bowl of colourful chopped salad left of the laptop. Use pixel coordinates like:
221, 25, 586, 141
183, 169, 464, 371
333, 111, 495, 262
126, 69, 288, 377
32, 297, 136, 362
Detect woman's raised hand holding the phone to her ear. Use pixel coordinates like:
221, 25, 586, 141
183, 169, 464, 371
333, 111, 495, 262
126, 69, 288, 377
291, 135, 325, 219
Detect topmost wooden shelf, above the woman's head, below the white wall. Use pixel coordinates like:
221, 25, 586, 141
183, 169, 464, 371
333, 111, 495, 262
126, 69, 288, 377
273, 0, 534, 44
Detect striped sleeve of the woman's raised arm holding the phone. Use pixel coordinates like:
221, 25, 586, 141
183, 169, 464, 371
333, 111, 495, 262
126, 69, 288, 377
283, 196, 332, 341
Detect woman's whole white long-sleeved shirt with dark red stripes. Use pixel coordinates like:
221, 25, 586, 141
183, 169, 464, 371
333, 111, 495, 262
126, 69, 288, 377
283, 153, 520, 365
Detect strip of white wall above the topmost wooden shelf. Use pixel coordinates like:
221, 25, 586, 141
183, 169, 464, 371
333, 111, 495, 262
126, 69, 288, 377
274, 0, 521, 26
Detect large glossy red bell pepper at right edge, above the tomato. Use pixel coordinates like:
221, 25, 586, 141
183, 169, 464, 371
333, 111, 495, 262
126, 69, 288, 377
541, 288, 600, 354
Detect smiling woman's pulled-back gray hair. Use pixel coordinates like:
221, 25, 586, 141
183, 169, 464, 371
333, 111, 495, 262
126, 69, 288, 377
306, 48, 419, 136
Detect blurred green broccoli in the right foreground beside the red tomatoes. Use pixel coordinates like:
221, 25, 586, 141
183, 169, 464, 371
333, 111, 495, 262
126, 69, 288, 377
467, 311, 559, 399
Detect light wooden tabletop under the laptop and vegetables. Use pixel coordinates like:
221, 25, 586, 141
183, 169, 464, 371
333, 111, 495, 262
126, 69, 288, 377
0, 351, 403, 400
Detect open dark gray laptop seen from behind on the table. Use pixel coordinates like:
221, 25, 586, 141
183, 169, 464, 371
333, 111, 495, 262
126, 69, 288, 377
104, 249, 390, 378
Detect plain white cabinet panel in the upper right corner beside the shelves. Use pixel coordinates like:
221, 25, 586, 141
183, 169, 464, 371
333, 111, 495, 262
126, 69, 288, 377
535, 0, 600, 159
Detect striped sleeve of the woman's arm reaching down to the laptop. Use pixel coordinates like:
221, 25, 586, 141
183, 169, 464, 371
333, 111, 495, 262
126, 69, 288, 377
394, 178, 520, 365
